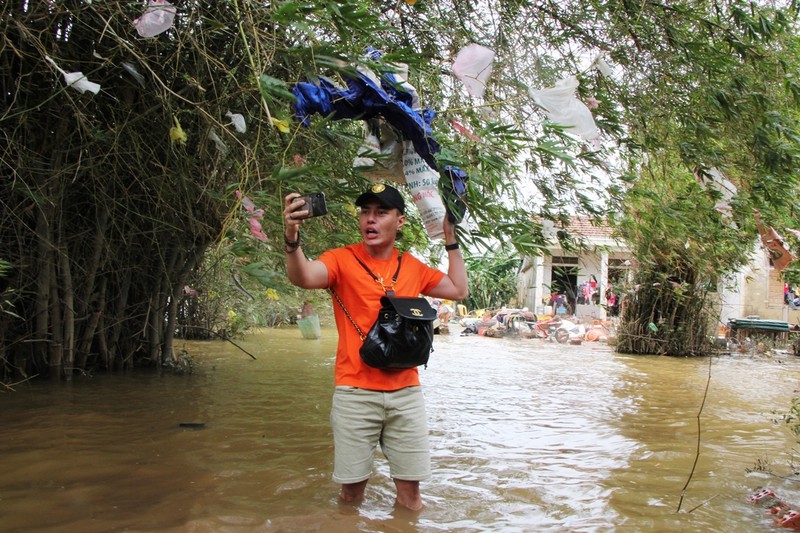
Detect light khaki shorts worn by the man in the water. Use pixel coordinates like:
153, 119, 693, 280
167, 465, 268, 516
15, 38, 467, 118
331, 386, 431, 483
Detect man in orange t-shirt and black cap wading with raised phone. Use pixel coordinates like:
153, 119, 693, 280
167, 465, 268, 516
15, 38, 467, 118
283, 184, 468, 511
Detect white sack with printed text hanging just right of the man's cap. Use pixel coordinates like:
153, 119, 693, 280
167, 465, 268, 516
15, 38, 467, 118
403, 141, 445, 239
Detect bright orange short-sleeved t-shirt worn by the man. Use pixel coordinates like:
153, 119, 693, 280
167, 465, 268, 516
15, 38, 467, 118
319, 242, 444, 391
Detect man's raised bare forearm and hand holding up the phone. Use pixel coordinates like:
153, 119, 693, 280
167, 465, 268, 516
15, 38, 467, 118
283, 192, 328, 289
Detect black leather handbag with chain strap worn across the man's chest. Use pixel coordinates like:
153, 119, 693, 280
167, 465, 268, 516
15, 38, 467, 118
329, 254, 436, 370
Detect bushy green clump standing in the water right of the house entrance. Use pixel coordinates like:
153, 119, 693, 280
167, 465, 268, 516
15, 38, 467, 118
617, 158, 754, 355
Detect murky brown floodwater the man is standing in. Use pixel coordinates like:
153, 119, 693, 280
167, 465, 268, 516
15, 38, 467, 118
0, 327, 800, 533
